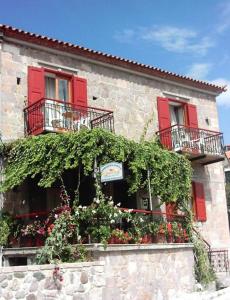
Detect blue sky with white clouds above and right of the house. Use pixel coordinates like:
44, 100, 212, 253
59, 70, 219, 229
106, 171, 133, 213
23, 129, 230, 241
0, 0, 230, 144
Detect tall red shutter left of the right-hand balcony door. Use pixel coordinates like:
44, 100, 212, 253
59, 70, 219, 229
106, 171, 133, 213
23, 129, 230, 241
157, 97, 172, 150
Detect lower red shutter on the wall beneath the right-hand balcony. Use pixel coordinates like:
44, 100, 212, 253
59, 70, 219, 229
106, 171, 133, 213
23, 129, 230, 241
193, 182, 207, 222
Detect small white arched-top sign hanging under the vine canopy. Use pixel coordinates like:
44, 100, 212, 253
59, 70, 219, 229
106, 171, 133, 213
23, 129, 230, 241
100, 162, 123, 182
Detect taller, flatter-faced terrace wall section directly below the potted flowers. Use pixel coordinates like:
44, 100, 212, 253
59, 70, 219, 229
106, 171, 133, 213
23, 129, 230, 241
94, 244, 195, 300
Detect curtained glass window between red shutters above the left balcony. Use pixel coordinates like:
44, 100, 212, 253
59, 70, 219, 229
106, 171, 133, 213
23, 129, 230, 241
45, 73, 71, 102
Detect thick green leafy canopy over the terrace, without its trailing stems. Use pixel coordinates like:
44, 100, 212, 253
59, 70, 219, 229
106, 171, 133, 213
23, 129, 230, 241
1, 129, 191, 208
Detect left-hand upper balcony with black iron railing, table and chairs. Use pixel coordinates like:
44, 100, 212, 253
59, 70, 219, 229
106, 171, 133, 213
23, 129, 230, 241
24, 98, 114, 135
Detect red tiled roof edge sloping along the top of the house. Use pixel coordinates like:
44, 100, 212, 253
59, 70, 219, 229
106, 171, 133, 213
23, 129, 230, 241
0, 24, 226, 94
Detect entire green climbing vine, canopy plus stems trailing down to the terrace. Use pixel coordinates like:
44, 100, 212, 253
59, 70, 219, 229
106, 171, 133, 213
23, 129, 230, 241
0, 128, 214, 283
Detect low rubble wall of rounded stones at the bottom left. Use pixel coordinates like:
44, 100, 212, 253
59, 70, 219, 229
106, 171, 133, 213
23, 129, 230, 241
0, 262, 105, 300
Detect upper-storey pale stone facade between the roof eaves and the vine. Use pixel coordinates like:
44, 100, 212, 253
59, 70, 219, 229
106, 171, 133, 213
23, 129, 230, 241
1, 42, 219, 140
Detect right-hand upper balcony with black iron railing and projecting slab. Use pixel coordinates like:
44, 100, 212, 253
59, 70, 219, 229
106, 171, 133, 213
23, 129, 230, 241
157, 125, 224, 165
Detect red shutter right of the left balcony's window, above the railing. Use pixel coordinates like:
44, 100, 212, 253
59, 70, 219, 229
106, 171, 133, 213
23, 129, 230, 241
72, 76, 87, 107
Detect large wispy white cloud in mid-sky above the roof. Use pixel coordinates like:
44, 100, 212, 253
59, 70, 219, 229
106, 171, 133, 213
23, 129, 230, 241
142, 26, 214, 55
